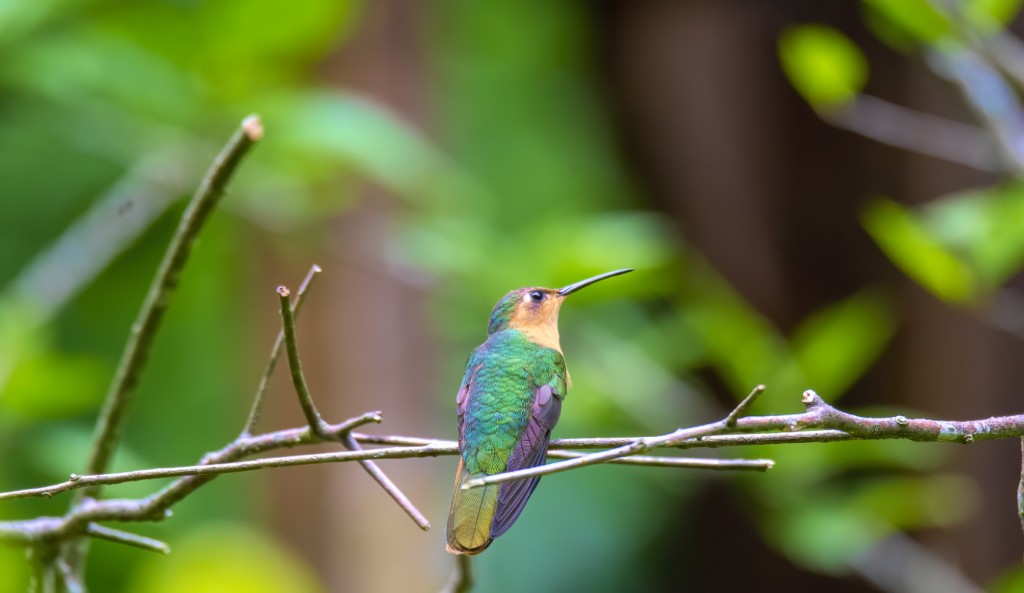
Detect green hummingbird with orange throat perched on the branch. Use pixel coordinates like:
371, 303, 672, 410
446, 269, 633, 555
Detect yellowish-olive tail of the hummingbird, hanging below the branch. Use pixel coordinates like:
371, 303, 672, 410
447, 459, 498, 556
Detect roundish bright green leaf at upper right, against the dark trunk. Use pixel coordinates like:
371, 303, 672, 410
778, 25, 867, 109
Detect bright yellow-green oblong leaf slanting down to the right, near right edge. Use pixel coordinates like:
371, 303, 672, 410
861, 198, 978, 303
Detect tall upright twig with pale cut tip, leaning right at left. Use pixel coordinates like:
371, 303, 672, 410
76, 116, 263, 487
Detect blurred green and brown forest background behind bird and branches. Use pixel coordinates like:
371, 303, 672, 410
0, 0, 1024, 593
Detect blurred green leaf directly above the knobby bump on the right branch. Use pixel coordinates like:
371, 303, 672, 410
793, 292, 895, 397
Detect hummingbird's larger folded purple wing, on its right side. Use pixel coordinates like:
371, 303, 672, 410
490, 385, 562, 538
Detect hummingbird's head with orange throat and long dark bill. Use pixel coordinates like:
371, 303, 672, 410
487, 269, 633, 350
